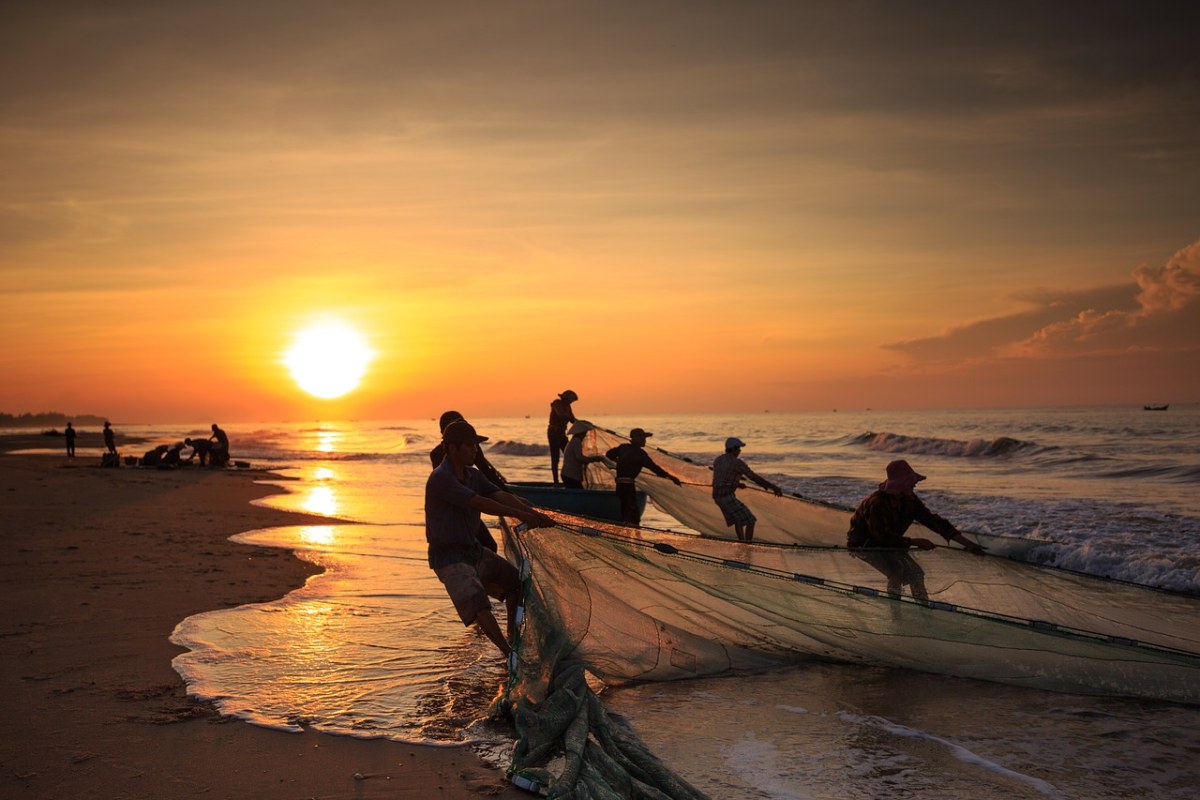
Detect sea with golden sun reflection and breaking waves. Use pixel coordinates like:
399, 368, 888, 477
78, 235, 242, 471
42, 403, 1200, 800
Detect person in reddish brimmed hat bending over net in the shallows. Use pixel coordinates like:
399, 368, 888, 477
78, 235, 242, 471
846, 459, 985, 600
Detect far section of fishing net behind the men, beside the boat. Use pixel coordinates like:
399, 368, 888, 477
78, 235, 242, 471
583, 428, 1045, 560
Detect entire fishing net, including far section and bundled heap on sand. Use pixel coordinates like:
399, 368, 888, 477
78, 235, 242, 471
494, 431, 1200, 800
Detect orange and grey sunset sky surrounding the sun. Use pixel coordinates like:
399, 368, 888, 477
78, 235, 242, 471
0, 0, 1200, 422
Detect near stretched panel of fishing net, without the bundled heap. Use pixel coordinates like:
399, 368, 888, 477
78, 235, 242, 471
501, 515, 1200, 703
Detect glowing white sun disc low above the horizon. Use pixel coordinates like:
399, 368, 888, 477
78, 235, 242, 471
283, 321, 374, 399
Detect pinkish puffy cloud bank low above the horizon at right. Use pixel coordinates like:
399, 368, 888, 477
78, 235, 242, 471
883, 241, 1200, 365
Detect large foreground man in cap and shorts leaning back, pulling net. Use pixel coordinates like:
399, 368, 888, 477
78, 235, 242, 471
425, 420, 554, 655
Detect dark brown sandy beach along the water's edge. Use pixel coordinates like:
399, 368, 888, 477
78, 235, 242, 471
0, 443, 529, 800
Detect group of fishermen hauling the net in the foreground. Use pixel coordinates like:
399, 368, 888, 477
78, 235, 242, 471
422, 390, 984, 656
